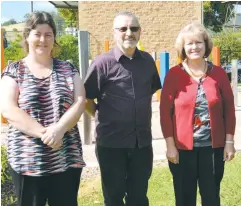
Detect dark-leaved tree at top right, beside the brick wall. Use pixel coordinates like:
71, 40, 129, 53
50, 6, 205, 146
203, 1, 234, 32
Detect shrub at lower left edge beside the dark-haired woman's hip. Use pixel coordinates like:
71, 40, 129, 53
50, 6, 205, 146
1, 145, 17, 206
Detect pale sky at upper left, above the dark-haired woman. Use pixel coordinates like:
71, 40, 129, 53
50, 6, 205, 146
1, 0, 57, 23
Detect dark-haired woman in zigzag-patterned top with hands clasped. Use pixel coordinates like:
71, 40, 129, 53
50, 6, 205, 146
1, 12, 85, 206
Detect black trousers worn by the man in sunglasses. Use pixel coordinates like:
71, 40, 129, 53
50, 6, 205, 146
96, 145, 153, 206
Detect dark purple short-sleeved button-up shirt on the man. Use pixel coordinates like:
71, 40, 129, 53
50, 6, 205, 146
85, 47, 161, 148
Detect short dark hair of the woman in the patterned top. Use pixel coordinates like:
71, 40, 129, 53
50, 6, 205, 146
23, 11, 58, 52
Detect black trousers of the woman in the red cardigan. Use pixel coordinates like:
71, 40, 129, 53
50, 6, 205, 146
169, 147, 224, 206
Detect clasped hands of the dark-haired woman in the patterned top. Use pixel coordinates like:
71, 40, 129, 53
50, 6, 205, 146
41, 124, 65, 149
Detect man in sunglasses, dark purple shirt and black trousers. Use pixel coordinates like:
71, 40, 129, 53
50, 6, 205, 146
85, 12, 161, 206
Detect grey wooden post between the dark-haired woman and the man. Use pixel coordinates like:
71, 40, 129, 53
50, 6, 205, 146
78, 31, 92, 145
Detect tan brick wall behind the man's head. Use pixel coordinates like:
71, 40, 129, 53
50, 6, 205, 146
79, 1, 202, 66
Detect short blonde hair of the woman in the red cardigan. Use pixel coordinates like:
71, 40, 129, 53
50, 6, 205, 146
175, 21, 213, 60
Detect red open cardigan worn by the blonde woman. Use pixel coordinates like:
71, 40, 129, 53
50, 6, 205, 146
160, 65, 236, 150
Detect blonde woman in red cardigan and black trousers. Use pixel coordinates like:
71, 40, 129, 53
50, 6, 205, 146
160, 22, 236, 206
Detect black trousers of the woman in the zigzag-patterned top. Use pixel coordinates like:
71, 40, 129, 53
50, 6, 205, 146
11, 168, 82, 206
